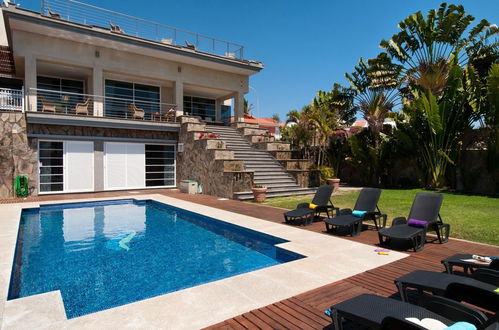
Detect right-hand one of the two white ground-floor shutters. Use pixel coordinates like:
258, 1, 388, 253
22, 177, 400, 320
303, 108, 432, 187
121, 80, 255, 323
104, 142, 145, 190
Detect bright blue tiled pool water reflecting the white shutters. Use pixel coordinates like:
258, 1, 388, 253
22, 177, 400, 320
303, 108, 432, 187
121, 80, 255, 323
9, 200, 303, 318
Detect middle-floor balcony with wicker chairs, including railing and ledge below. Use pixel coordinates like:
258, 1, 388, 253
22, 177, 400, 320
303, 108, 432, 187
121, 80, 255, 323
26, 88, 179, 130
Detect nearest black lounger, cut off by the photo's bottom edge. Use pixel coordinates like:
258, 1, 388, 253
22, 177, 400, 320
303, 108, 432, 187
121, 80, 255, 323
331, 294, 496, 330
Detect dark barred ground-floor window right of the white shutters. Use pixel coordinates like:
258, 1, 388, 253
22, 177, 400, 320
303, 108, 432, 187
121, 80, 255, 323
146, 144, 175, 187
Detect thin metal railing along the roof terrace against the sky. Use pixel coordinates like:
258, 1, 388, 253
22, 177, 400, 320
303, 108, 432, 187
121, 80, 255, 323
41, 0, 244, 59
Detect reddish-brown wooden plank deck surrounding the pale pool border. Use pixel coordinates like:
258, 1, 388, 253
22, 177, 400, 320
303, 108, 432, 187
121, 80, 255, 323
0, 189, 499, 329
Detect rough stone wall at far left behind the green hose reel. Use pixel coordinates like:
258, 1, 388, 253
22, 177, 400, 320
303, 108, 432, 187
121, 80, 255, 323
0, 112, 38, 198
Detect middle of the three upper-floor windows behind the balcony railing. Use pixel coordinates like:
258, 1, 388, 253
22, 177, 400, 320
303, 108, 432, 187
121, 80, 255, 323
105, 80, 160, 119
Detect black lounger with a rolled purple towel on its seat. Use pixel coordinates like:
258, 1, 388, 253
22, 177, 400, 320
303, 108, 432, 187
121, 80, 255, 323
378, 193, 450, 252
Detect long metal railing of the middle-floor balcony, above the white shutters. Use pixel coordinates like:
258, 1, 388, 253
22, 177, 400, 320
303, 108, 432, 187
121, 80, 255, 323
27, 88, 177, 122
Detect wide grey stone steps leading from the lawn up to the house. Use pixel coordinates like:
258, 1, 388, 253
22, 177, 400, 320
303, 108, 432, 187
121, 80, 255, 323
206, 125, 316, 200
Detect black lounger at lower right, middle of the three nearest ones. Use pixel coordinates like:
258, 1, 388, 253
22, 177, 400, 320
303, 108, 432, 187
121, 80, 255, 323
394, 270, 499, 313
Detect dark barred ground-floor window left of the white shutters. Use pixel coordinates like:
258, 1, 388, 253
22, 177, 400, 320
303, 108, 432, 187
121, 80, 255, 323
38, 141, 64, 192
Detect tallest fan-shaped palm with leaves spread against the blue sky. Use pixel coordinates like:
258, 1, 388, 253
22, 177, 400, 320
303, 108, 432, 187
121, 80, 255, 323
380, 3, 497, 187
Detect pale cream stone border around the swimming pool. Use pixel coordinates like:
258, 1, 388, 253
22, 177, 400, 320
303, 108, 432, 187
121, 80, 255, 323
0, 194, 408, 329
